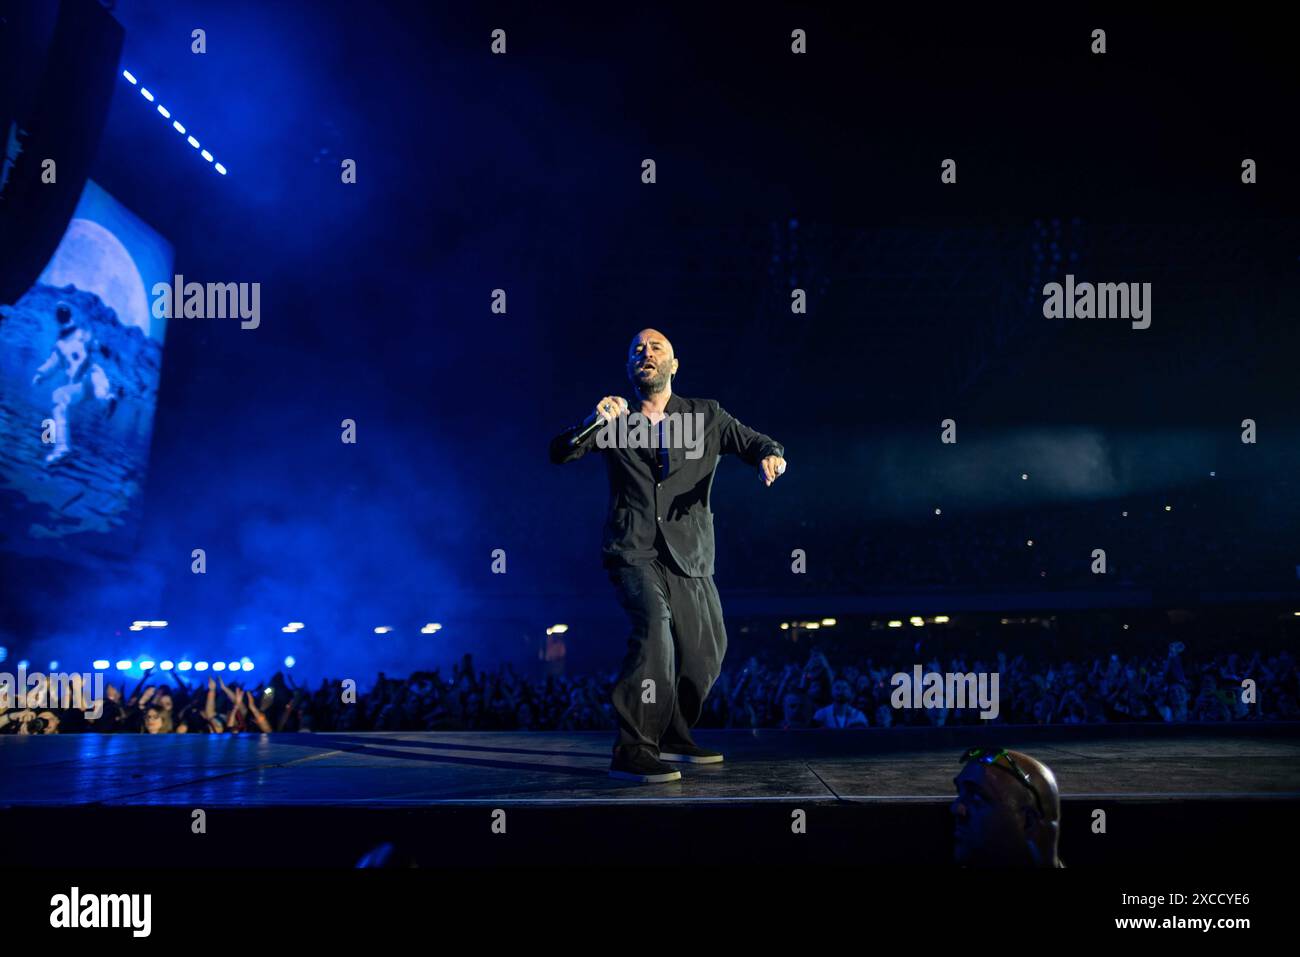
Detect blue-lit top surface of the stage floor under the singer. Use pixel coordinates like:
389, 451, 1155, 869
0, 726, 1300, 807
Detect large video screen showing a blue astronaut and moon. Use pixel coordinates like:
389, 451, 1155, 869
0, 181, 173, 553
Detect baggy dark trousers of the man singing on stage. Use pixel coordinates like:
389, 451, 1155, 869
608, 553, 727, 755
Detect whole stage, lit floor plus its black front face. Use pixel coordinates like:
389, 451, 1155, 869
0, 726, 1300, 874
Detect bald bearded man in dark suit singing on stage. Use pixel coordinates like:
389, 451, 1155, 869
550, 329, 785, 784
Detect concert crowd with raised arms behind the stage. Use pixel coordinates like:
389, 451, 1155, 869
0, 631, 1300, 735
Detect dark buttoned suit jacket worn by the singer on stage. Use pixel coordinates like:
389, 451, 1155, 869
550, 393, 785, 577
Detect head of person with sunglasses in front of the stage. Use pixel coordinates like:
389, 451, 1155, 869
949, 748, 1065, 867
